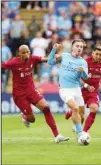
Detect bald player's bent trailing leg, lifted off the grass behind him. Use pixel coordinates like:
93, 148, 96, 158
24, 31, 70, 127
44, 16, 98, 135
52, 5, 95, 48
14, 96, 35, 126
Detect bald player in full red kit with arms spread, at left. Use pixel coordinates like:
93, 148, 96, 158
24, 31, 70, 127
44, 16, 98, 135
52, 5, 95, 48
2, 45, 69, 143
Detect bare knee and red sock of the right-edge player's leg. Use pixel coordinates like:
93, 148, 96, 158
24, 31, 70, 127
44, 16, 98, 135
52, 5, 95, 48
83, 103, 98, 132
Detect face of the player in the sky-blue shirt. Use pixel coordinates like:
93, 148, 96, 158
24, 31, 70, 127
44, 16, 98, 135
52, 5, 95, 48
72, 42, 84, 56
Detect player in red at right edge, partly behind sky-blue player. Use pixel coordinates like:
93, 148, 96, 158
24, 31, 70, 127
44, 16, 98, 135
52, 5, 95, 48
65, 45, 101, 132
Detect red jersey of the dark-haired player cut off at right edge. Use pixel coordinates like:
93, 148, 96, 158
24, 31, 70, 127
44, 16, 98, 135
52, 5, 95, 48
82, 56, 101, 92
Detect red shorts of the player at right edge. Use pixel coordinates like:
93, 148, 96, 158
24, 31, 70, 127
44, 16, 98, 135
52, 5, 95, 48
82, 90, 99, 107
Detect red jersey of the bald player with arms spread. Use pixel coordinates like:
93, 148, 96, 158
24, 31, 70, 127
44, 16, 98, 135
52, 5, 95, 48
2, 56, 41, 96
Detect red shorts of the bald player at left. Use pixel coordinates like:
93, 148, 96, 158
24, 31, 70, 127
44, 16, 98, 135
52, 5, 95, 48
13, 89, 43, 115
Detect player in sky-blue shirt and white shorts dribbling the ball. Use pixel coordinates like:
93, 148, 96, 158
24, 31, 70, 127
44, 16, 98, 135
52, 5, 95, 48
48, 39, 88, 142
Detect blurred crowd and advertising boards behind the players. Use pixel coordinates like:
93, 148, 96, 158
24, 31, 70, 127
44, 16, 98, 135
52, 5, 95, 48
1, 1, 101, 114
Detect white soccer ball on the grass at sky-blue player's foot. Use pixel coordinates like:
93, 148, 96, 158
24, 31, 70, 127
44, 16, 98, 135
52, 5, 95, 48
78, 132, 91, 145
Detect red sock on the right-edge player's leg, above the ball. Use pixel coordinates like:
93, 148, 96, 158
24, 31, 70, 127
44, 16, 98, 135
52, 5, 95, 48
83, 112, 96, 132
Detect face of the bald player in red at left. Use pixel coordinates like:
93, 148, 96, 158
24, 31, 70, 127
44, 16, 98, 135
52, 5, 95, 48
19, 48, 30, 62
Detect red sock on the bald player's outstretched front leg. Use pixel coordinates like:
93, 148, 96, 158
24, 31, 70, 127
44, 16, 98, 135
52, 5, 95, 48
43, 106, 59, 137
